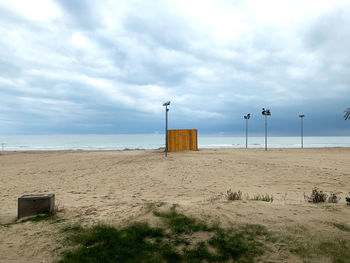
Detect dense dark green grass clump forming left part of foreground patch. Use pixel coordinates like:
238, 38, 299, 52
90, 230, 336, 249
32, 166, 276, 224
60, 223, 173, 263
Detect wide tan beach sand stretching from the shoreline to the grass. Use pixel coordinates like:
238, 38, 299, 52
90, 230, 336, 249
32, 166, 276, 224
0, 148, 350, 263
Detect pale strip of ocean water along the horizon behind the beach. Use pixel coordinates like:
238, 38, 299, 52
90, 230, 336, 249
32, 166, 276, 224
0, 134, 350, 151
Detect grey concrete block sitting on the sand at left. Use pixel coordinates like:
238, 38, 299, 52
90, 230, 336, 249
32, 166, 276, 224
18, 194, 55, 219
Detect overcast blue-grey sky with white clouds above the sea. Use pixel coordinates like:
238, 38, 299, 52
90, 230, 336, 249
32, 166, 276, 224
0, 0, 350, 136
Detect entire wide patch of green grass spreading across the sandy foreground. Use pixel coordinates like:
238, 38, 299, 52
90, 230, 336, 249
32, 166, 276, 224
59, 206, 269, 263
